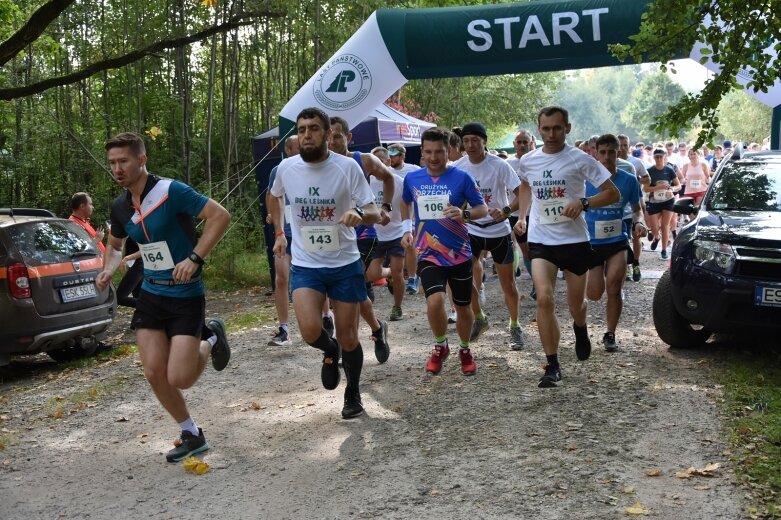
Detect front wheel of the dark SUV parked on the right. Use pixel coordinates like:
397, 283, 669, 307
653, 271, 711, 348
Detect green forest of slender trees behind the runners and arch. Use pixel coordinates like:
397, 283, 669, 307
0, 0, 770, 284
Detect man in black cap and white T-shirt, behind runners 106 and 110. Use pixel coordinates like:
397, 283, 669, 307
453, 123, 523, 350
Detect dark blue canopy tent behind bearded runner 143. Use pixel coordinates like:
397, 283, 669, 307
252, 104, 435, 285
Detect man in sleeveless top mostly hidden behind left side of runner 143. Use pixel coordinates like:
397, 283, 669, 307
266, 135, 298, 347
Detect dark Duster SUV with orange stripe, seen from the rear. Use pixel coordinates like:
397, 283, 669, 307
0, 208, 116, 365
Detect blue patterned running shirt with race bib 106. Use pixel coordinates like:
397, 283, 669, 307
402, 166, 485, 266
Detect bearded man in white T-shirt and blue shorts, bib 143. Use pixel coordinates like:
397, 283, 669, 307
270, 108, 380, 419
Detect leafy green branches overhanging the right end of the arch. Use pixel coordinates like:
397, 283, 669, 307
612, 0, 781, 144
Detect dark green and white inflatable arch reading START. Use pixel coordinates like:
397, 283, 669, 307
279, 0, 781, 149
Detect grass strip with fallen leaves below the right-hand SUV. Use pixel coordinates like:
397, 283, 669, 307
722, 350, 781, 518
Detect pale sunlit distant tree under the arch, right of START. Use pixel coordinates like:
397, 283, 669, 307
621, 72, 685, 141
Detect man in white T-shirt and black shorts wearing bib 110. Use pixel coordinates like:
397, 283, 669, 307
515, 106, 619, 388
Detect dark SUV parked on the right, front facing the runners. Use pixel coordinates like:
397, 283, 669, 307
653, 146, 781, 347
